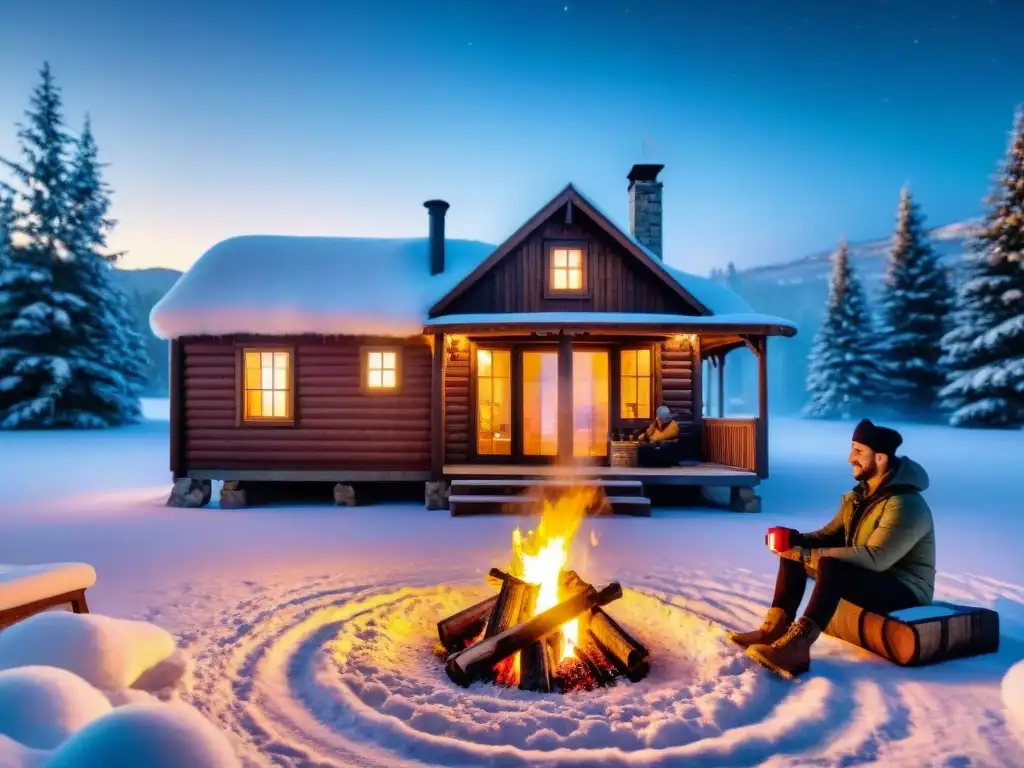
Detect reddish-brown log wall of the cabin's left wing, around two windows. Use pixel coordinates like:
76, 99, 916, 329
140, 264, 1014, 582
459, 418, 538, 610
182, 337, 431, 470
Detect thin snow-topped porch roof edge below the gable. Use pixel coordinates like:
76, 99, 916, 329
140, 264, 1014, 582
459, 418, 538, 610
424, 312, 797, 336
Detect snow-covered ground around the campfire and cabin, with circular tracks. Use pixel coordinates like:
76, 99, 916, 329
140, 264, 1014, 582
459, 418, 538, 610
0, 401, 1024, 766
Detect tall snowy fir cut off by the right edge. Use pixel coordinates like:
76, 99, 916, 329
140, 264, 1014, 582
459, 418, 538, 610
941, 109, 1024, 428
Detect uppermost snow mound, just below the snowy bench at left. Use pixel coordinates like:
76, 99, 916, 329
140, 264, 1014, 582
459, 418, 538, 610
0, 612, 174, 691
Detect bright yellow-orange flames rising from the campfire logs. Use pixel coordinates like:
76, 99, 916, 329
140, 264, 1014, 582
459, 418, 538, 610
509, 487, 598, 663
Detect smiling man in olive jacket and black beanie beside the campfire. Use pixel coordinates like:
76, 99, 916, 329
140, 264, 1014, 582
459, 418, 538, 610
729, 419, 935, 678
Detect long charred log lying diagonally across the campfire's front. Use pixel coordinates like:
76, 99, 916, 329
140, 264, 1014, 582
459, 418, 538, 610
444, 582, 623, 687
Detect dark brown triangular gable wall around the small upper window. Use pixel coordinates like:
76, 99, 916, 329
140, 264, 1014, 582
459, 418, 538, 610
444, 211, 698, 315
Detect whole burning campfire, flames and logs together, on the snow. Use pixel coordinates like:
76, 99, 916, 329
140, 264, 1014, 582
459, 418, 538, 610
437, 488, 649, 693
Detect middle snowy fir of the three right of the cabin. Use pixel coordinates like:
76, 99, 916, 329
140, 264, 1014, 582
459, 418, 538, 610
878, 187, 953, 421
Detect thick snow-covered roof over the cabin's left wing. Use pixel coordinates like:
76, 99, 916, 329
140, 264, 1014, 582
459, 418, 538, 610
150, 236, 495, 339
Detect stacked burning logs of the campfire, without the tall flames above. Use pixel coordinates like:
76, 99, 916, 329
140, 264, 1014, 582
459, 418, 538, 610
437, 568, 650, 693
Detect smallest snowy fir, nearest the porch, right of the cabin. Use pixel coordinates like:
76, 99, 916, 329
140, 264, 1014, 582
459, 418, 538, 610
803, 241, 884, 419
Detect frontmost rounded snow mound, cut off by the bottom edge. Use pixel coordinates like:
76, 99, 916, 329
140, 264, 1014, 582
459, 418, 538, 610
46, 703, 239, 768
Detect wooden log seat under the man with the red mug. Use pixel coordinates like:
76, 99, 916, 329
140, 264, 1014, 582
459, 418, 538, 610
825, 600, 999, 667
